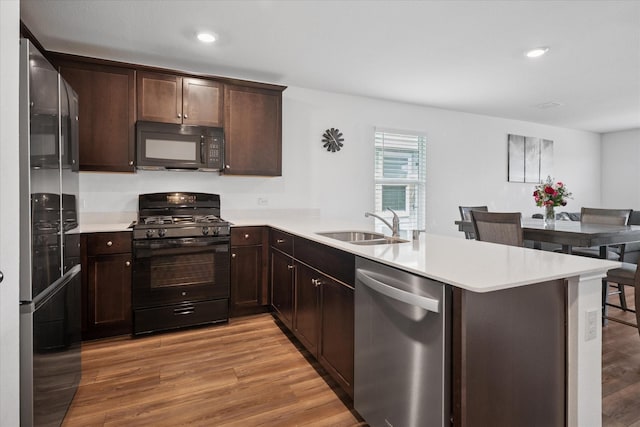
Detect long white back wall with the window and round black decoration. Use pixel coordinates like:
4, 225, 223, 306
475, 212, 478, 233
80, 87, 601, 237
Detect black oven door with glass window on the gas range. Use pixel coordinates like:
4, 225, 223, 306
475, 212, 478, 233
132, 237, 230, 309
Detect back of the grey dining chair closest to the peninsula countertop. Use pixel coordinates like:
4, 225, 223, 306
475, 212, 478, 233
471, 210, 524, 246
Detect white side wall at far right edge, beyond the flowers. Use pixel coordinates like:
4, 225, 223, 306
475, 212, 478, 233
602, 129, 640, 210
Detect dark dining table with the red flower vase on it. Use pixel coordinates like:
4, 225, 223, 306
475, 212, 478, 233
455, 218, 640, 259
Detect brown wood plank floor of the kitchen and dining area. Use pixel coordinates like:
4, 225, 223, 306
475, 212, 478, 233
63, 308, 640, 427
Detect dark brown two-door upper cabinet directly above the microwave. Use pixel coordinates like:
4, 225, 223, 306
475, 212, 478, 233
137, 71, 223, 127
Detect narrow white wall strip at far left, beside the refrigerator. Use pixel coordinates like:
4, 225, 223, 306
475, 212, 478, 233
0, 0, 20, 427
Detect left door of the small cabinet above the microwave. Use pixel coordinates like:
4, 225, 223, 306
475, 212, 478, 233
137, 71, 182, 124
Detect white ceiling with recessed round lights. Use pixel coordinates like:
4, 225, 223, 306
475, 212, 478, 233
20, 0, 640, 133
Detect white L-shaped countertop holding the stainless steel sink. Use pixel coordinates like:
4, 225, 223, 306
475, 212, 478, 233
227, 215, 620, 292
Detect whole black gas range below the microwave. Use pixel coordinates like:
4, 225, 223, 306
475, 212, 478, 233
132, 192, 230, 335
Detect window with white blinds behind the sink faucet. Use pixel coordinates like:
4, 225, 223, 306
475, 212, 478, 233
375, 129, 427, 230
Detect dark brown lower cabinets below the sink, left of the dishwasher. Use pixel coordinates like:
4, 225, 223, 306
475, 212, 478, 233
271, 229, 355, 397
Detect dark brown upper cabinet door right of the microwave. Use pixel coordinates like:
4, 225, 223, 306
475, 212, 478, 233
224, 85, 282, 176
